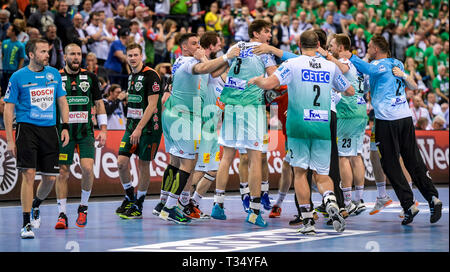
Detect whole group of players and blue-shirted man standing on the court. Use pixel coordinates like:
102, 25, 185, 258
4, 20, 442, 238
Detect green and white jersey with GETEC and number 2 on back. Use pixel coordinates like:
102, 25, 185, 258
274, 55, 350, 140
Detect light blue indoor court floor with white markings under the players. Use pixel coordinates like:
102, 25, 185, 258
0, 186, 449, 252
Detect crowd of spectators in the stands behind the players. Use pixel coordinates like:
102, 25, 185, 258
0, 0, 449, 129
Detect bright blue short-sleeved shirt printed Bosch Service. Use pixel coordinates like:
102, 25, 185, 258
4, 66, 66, 127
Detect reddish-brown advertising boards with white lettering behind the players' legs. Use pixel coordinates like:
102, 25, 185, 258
0, 130, 449, 200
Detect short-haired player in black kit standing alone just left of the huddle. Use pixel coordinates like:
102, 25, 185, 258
116, 43, 163, 219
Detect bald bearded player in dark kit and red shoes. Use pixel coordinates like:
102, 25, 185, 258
29, 43, 107, 229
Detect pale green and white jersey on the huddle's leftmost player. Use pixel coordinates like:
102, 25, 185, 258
165, 56, 201, 114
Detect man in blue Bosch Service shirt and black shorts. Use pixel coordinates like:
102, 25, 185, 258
4, 39, 69, 239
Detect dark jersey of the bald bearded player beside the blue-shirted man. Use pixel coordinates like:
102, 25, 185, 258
57, 69, 102, 139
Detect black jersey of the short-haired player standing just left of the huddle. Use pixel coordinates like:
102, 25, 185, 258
126, 66, 162, 134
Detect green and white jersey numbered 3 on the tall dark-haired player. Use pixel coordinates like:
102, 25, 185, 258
220, 42, 276, 105
